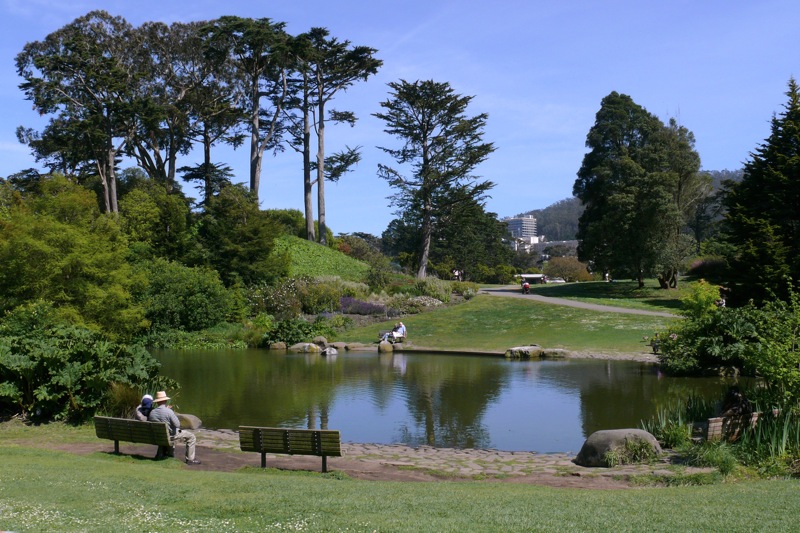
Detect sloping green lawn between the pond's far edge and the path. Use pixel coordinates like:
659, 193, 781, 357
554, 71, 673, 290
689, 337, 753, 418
342, 290, 679, 353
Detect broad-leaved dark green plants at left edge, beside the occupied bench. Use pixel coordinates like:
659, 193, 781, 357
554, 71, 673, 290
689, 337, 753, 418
0, 302, 172, 421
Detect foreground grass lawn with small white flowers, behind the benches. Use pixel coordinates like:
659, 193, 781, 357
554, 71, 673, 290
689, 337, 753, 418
0, 442, 800, 532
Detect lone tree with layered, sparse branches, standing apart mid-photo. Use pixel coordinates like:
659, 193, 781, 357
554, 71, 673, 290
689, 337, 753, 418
375, 80, 494, 278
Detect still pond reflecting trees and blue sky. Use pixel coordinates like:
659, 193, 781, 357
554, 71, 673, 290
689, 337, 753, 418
154, 350, 730, 453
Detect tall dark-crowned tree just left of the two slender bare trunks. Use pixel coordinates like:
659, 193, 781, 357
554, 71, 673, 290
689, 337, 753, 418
201, 16, 293, 198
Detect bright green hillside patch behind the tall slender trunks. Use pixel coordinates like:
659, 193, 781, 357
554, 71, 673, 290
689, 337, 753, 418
272, 235, 369, 281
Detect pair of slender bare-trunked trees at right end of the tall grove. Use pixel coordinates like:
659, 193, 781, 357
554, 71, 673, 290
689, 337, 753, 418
291, 28, 383, 244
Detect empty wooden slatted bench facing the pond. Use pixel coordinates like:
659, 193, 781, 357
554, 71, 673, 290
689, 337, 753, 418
234, 426, 342, 472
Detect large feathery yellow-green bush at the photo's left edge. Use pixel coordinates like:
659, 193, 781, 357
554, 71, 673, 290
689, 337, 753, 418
0, 177, 148, 338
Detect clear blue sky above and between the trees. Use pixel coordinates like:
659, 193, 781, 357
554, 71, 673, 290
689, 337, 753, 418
0, 0, 800, 235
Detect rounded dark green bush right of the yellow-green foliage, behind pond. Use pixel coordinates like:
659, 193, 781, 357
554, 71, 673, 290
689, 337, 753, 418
131, 259, 237, 331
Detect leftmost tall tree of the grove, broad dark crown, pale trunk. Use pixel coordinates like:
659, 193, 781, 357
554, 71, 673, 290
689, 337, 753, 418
16, 11, 141, 212
